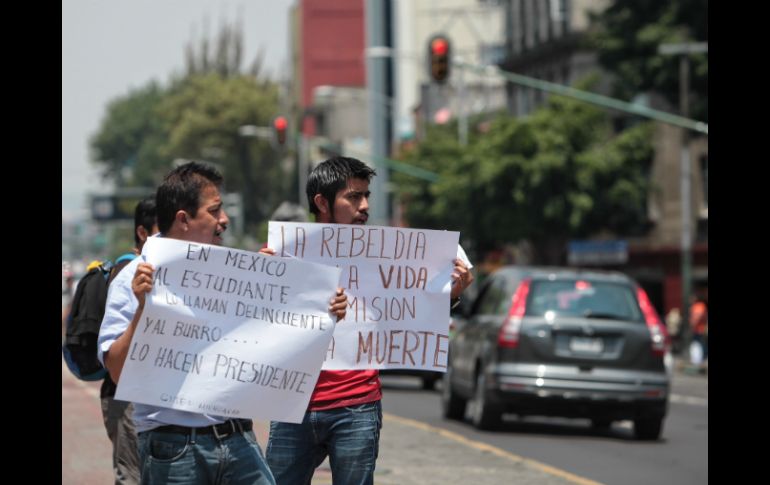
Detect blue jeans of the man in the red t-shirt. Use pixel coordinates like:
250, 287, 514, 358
267, 401, 382, 485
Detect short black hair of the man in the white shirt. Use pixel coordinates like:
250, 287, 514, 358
155, 162, 224, 234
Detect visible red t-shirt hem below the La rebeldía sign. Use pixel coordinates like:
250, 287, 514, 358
308, 370, 382, 411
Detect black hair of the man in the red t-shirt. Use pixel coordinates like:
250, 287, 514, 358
305, 157, 377, 216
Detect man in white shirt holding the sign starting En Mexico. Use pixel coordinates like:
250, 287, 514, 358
98, 162, 347, 484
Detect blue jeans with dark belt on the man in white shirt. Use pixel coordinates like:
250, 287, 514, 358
139, 430, 275, 485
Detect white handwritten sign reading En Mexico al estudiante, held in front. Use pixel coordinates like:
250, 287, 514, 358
115, 237, 340, 423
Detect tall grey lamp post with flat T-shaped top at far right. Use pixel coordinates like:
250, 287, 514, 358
658, 42, 708, 352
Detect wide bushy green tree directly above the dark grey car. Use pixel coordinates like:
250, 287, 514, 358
395, 89, 653, 264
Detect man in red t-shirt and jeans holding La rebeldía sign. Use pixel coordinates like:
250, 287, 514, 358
267, 157, 473, 485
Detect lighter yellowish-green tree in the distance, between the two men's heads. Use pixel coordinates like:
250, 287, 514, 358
159, 73, 285, 225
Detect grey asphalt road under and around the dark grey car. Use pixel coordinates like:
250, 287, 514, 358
383, 366, 708, 485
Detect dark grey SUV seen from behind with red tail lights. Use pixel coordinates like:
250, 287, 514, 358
442, 266, 669, 440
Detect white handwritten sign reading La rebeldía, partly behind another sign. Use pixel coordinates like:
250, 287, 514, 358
267, 221, 460, 372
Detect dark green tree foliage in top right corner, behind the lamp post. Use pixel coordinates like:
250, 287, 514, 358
591, 0, 708, 122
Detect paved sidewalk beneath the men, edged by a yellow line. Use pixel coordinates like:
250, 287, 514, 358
62, 362, 596, 485
